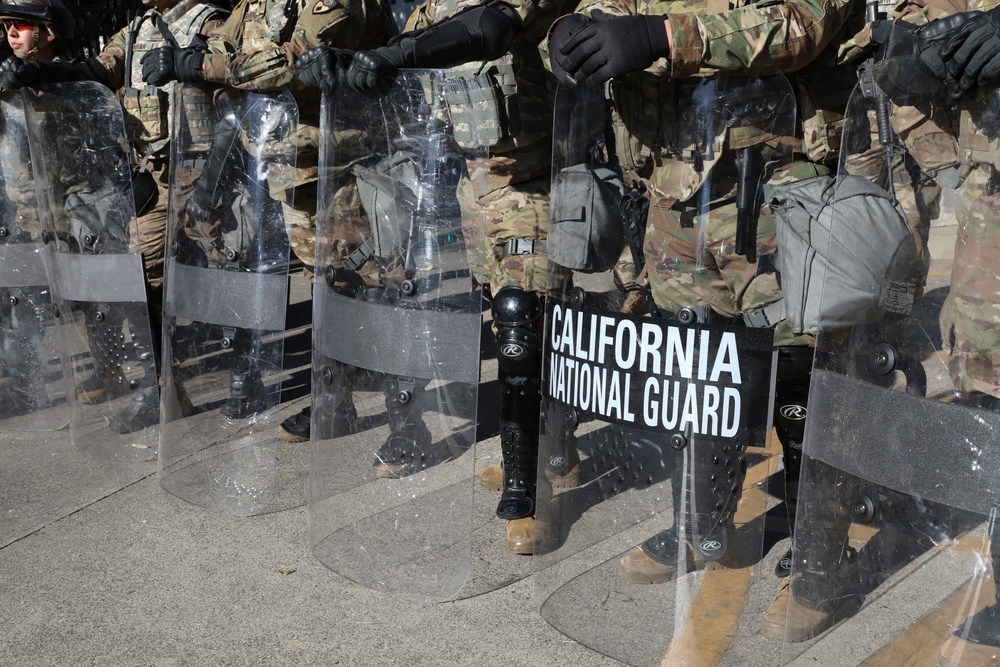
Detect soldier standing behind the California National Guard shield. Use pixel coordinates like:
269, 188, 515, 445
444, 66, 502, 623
548, 0, 858, 584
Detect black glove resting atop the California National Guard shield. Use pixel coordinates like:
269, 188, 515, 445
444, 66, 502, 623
549, 9, 670, 86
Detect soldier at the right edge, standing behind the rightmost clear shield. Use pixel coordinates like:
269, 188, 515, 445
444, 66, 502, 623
762, 3, 1000, 656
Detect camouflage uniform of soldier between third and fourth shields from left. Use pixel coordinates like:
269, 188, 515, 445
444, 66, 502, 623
195, 0, 396, 267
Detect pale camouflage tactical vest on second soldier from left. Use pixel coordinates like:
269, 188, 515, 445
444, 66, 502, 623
120, 0, 222, 157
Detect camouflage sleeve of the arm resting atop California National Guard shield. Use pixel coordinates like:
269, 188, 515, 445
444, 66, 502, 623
668, 0, 851, 77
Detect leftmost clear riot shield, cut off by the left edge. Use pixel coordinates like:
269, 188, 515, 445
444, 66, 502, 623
0, 93, 69, 431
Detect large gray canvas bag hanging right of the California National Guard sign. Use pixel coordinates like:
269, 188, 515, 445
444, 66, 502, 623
766, 176, 920, 333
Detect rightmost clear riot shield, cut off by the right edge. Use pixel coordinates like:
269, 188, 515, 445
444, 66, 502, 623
778, 40, 1000, 665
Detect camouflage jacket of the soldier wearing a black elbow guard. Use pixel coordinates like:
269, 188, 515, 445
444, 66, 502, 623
406, 0, 576, 191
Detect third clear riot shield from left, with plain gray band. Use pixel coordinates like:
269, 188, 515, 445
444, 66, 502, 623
160, 86, 298, 516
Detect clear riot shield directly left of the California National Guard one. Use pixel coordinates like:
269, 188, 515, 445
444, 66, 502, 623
309, 70, 487, 601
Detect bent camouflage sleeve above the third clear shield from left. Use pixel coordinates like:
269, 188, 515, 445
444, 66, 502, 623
201, 0, 368, 91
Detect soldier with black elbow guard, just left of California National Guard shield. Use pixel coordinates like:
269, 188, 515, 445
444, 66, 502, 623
304, 0, 579, 554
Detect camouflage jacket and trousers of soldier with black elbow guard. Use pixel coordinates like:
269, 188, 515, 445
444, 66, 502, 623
406, 0, 572, 293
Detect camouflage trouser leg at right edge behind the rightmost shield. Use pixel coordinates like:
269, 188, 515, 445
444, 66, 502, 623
940, 167, 1000, 397
